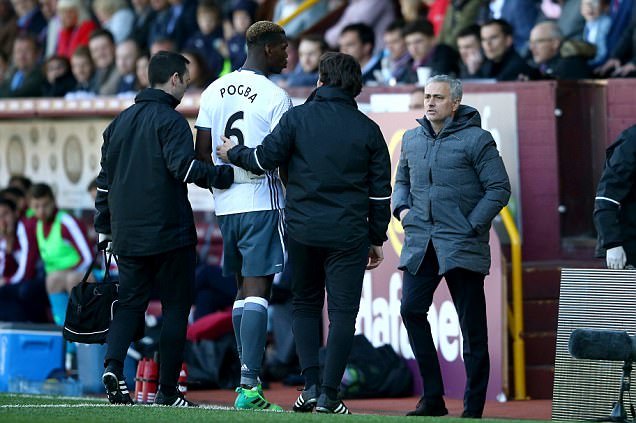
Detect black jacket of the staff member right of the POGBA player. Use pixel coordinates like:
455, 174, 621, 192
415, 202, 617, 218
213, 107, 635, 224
228, 86, 391, 248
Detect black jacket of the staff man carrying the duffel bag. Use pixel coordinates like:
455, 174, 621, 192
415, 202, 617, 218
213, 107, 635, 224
95, 88, 234, 256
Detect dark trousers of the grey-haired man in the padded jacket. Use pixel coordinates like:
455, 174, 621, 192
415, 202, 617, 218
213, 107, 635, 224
400, 244, 490, 415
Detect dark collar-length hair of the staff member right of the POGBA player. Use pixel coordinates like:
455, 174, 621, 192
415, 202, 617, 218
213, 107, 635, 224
318, 52, 362, 97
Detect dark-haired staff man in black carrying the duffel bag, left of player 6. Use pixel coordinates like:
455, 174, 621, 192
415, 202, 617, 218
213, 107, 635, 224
95, 52, 234, 407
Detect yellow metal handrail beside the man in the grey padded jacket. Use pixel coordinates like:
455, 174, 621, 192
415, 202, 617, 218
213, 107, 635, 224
499, 206, 528, 400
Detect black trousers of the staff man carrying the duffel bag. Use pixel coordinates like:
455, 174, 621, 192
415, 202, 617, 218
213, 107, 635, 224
106, 245, 196, 387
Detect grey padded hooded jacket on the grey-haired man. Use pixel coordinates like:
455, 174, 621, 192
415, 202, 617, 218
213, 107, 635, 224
393, 105, 510, 275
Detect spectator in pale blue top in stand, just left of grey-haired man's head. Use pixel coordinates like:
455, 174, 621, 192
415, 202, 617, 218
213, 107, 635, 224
381, 20, 411, 85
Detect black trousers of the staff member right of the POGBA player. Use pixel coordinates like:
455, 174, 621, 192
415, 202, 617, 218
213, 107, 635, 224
288, 237, 369, 391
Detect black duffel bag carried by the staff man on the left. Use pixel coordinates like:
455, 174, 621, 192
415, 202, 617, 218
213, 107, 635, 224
62, 251, 119, 344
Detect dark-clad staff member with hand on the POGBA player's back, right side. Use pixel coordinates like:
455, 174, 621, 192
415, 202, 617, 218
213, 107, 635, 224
217, 53, 391, 414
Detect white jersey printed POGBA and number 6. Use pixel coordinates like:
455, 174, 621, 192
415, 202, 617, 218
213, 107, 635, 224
195, 69, 292, 216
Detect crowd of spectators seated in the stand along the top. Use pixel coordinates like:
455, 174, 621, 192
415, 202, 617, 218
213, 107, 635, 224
0, 0, 636, 99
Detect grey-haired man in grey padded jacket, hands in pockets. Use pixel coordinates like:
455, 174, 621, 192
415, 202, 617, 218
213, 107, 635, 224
393, 75, 510, 418
